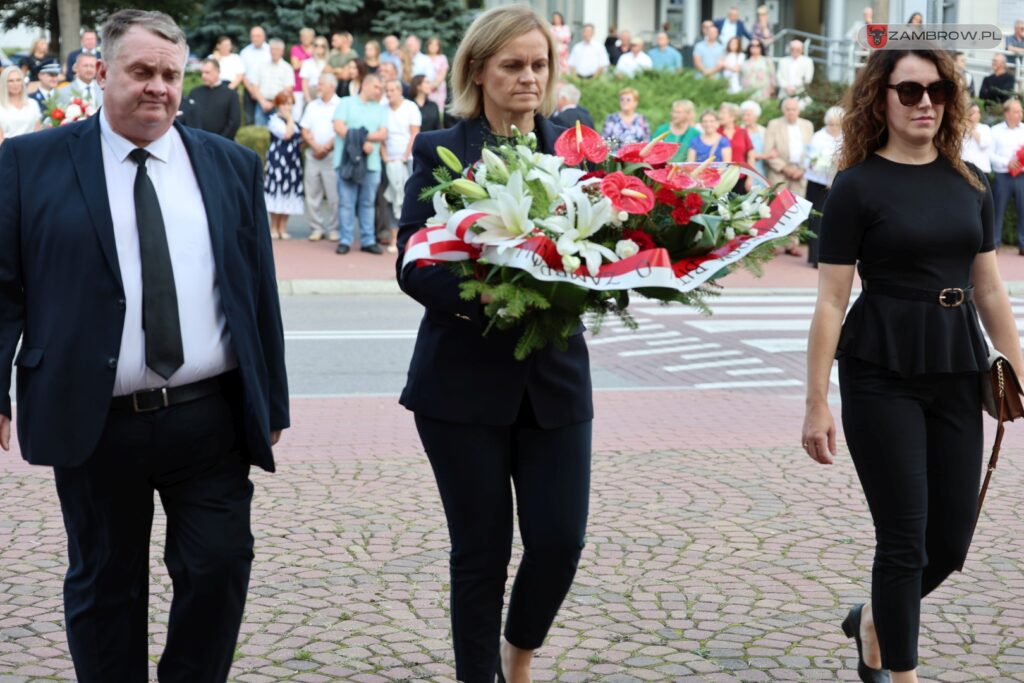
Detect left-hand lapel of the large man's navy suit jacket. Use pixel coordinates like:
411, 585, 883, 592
68, 113, 124, 290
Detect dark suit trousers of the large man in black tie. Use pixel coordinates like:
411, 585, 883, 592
55, 378, 253, 683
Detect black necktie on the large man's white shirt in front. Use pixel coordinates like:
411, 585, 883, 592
128, 150, 185, 380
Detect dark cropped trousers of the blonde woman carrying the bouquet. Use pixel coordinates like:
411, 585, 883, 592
416, 401, 592, 683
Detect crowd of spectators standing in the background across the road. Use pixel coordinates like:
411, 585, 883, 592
6, 5, 1024, 255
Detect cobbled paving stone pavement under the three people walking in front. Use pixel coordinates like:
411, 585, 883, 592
0, 392, 1024, 683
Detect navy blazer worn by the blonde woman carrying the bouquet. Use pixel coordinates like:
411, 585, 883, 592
397, 116, 594, 429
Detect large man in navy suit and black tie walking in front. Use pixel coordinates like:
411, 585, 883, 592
0, 10, 289, 683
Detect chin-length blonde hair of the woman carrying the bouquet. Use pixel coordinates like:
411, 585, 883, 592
449, 5, 558, 119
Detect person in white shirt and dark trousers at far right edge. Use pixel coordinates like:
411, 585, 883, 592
988, 98, 1024, 250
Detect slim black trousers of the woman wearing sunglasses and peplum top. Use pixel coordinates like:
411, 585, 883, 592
839, 357, 983, 671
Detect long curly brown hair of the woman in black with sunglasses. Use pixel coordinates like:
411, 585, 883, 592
837, 49, 985, 190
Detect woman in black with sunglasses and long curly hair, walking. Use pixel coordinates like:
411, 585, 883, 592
803, 50, 1024, 683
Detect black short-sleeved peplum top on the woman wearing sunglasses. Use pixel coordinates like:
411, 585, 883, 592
818, 155, 995, 377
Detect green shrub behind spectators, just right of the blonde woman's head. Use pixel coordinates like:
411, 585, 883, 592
567, 70, 780, 133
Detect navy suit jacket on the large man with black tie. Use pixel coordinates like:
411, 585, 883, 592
0, 114, 289, 471
